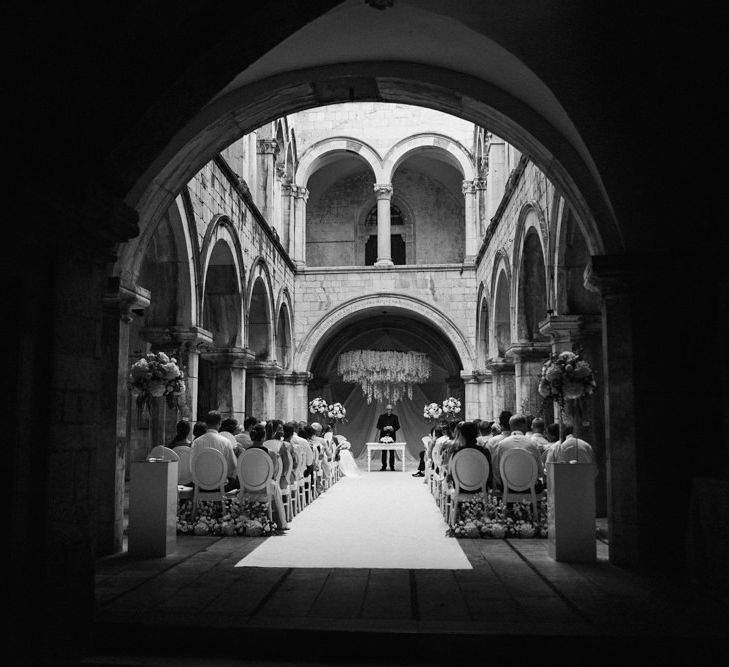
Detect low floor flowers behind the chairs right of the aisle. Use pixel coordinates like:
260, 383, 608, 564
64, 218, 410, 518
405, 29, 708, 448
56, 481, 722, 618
446, 492, 547, 539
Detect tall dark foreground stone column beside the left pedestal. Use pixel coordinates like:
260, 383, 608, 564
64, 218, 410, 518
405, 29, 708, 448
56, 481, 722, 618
96, 278, 150, 556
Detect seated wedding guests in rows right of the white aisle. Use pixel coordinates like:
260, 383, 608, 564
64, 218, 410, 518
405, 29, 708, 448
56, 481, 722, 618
424, 411, 594, 493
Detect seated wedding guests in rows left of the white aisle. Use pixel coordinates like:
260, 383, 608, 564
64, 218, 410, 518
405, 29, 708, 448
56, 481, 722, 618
168, 410, 336, 530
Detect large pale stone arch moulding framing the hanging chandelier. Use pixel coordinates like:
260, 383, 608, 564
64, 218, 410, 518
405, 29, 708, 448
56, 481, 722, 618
295, 292, 474, 371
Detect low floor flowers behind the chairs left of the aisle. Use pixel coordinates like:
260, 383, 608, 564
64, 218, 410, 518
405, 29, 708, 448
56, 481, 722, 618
177, 496, 278, 537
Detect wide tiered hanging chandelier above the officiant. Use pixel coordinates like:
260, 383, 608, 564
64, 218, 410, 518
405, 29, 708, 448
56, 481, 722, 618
337, 350, 430, 403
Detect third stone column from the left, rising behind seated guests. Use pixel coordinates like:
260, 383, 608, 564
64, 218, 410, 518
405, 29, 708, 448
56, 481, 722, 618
202, 347, 253, 424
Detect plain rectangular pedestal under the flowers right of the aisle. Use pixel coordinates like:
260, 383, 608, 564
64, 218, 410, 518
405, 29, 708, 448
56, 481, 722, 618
547, 463, 597, 563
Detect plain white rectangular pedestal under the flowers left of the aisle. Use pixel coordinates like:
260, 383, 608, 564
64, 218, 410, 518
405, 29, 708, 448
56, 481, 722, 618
129, 461, 178, 557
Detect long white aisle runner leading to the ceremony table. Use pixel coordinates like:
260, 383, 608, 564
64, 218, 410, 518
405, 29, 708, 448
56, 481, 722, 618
236, 471, 472, 570
